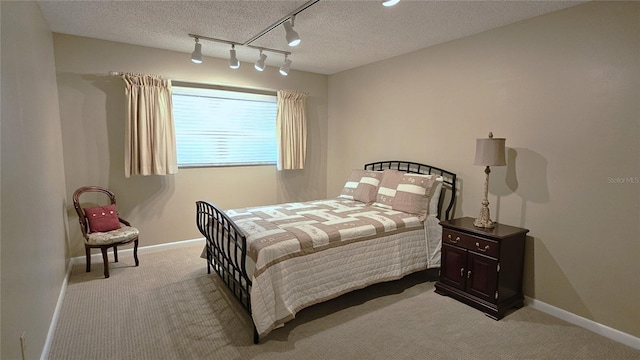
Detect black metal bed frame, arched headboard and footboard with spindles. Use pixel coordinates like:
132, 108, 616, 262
196, 161, 456, 344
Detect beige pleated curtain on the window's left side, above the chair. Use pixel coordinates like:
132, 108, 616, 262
122, 74, 178, 177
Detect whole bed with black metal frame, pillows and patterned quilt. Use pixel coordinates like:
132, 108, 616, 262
196, 161, 456, 343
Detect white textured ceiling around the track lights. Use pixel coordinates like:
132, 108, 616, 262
38, 0, 584, 74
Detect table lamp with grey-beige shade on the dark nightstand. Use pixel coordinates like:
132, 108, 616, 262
473, 132, 507, 229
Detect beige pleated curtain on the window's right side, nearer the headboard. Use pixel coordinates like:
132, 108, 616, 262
276, 90, 308, 170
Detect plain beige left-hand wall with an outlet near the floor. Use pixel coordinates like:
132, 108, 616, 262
0, 1, 67, 359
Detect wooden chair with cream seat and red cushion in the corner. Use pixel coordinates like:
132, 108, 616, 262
73, 186, 139, 278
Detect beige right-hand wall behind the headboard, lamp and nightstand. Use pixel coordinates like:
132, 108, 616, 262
327, 2, 640, 336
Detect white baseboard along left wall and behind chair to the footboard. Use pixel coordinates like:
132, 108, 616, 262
40, 238, 205, 360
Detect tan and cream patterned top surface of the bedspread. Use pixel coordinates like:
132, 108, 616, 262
227, 198, 423, 277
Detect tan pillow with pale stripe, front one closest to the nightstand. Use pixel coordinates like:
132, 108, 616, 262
391, 174, 436, 220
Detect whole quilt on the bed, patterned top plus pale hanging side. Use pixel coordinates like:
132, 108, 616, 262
226, 198, 429, 336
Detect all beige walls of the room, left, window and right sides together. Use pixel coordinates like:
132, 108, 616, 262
0, 2, 640, 359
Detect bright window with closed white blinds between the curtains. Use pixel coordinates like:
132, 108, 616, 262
172, 86, 277, 167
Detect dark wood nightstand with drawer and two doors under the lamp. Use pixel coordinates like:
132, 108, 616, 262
435, 217, 529, 320
